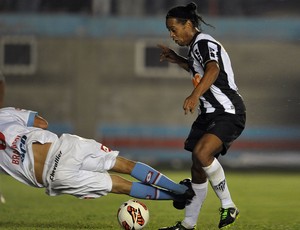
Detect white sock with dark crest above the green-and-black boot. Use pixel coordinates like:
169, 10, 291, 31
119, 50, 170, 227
203, 158, 235, 208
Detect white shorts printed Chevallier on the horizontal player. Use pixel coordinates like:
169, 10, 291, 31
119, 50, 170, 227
43, 134, 119, 198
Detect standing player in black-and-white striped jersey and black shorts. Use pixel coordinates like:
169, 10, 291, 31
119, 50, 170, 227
159, 3, 246, 230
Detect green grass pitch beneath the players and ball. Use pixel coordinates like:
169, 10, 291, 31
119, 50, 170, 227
0, 171, 300, 230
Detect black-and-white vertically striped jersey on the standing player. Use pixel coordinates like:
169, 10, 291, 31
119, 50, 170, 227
188, 33, 246, 114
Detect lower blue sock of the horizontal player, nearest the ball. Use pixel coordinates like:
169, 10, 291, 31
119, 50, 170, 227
129, 182, 174, 200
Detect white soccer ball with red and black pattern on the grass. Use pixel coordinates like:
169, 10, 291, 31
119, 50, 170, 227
117, 199, 149, 230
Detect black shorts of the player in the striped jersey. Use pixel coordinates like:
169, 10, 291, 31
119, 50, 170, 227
184, 113, 246, 157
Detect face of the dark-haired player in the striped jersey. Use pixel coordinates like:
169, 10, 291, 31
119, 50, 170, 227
166, 18, 193, 46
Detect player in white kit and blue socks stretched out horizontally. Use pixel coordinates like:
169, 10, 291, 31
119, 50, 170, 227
0, 107, 194, 202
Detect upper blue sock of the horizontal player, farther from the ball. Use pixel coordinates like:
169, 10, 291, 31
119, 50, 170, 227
131, 162, 187, 194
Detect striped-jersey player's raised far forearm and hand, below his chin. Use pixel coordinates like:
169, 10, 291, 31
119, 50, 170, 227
157, 44, 190, 72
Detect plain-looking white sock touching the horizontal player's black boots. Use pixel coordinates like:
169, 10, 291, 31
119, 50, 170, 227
182, 181, 208, 228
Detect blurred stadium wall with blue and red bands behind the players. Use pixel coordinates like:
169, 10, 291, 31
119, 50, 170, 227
0, 0, 300, 171
